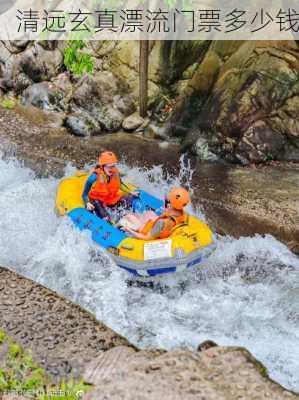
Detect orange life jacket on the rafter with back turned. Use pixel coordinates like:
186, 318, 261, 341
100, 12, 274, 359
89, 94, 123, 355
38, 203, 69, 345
139, 211, 187, 239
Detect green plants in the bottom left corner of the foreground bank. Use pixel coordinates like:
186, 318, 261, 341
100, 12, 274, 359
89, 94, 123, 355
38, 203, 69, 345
0, 330, 91, 400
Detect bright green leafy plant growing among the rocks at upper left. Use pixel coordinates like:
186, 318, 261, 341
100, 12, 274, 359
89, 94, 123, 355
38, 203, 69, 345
64, 40, 94, 76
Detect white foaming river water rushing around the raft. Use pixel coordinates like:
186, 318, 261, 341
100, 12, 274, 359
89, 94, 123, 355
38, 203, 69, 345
0, 152, 299, 391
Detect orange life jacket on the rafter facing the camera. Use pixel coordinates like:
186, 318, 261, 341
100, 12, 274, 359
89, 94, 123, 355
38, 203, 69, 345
88, 168, 123, 206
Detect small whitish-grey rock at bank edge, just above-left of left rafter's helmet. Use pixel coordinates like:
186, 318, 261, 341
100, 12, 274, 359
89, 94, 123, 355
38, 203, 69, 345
64, 113, 101, 136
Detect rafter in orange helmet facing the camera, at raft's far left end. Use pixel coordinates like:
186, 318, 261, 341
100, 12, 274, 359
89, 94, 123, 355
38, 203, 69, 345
82, 151, 138, 220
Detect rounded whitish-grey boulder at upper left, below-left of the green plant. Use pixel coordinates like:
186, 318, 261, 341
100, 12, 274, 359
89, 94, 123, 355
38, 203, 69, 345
22, 82, 66, 111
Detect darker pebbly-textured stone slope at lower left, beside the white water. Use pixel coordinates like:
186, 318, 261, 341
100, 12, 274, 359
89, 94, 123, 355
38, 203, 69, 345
0, 266, 132, 382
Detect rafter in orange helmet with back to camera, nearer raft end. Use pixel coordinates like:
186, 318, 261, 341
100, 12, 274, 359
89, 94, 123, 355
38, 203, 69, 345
120, 188, 190, 240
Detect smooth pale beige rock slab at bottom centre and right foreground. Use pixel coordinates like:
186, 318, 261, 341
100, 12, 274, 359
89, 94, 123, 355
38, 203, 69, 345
83, 347, 296, 400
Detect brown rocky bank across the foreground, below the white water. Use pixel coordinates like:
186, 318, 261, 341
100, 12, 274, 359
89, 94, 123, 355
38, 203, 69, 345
0, 268, 298, 400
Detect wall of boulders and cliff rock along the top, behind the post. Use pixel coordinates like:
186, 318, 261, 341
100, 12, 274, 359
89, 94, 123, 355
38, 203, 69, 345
0, 40, 299, 164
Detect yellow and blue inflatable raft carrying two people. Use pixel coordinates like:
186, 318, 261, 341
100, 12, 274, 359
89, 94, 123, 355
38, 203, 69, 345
56, 171, 214, 278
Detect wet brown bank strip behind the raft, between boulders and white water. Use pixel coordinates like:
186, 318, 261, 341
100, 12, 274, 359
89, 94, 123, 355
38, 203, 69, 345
0, 106, 299, 252
